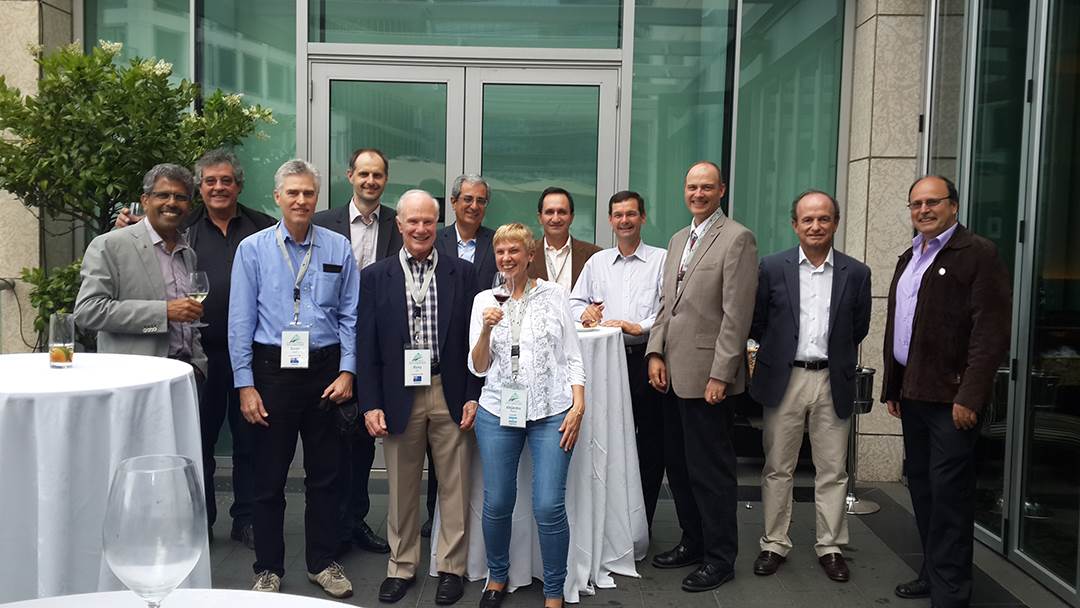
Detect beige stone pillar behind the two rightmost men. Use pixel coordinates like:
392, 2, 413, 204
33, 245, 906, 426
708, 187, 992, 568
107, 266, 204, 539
845, 0, 927, 482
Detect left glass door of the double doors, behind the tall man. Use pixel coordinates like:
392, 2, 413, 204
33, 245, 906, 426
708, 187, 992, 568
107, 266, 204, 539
310, 64, 464, 208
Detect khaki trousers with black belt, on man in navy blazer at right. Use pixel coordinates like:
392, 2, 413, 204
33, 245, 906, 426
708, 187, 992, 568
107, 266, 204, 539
760, 367, 851, 557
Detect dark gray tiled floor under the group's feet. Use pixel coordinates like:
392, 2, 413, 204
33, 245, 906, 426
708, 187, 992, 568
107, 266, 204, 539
203, 470, 1064, 608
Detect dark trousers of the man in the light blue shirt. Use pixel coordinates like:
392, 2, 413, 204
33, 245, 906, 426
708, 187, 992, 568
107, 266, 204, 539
252, 344, 341, 577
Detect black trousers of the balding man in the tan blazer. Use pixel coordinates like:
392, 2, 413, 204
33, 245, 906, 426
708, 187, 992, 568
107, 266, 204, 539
664, 392, 739, 570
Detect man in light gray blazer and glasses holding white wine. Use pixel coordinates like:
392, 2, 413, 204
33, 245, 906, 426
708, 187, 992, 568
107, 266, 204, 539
75, 164, 206, 380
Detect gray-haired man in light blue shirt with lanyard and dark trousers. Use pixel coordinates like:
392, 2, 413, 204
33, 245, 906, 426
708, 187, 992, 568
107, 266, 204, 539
229, 159, 360, 597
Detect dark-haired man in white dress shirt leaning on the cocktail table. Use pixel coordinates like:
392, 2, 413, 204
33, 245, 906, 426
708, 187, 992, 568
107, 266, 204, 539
570, 190, 665, 529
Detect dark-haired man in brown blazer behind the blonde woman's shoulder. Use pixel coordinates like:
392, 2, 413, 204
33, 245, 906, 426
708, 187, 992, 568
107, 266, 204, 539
527, 186, 600, 294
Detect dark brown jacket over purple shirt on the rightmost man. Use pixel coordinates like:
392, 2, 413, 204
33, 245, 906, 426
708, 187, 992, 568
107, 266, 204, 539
881, 226, 1012, 411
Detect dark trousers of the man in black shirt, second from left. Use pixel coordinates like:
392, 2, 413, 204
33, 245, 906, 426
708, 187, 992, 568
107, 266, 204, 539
199, 349, 255, 529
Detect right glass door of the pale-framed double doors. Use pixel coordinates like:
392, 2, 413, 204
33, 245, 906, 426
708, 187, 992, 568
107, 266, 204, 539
464, 68, 618, 246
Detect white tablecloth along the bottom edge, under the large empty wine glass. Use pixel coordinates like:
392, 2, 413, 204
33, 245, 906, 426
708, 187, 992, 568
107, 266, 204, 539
4, 589, 343, 608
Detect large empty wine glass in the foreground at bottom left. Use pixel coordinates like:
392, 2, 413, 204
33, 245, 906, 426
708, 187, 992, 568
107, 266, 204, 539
102, 455, 206, 608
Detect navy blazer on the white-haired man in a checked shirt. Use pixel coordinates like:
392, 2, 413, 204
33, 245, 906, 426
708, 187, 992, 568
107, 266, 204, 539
356, 249, 483, 434
